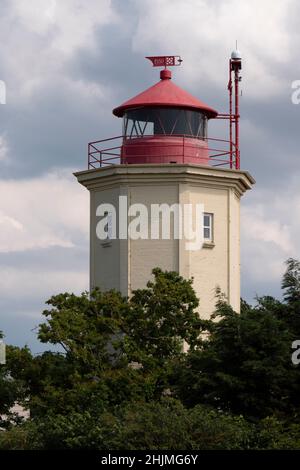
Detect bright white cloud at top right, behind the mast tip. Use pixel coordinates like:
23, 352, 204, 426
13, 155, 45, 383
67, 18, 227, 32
133, 0, 299, 99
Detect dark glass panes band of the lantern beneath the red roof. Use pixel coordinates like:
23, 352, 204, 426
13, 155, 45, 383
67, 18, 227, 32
123, 107, 207, 139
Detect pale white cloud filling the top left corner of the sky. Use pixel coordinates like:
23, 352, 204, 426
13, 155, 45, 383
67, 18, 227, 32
0, 0, 119, 105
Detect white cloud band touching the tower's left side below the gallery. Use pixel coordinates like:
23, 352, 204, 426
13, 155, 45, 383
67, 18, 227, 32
0, 170, 89, 252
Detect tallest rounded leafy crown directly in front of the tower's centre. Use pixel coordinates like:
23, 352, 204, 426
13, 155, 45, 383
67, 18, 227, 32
124, 268, 199, 368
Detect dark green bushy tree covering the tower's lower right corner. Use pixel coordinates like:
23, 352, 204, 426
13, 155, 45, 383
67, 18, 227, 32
174, 298, 300, 419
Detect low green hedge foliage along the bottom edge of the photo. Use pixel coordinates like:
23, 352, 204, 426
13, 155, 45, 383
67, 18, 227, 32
0, 399, 253, 450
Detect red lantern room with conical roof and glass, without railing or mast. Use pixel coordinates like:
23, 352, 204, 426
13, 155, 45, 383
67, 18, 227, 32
113, 69, 218, 165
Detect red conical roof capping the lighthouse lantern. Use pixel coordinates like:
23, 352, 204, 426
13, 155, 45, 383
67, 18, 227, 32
113, 70, 218, 118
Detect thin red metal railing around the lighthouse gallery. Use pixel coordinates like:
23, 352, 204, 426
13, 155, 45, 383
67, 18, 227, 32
88, 135, 238, 169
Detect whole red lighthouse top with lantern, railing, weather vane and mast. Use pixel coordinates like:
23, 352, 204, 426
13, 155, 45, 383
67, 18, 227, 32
88, 51, 241, 169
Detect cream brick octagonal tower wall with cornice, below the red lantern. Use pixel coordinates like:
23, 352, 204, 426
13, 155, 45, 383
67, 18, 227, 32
76, 164, 254, 318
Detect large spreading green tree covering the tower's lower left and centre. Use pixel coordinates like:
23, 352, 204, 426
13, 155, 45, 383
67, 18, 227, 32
15, 269, 199, 417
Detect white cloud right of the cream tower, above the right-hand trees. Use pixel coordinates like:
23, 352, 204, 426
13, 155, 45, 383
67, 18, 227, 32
241, 175, 300, 285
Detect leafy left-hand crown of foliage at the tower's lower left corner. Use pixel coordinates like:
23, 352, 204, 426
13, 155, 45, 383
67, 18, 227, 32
38, 289, 128, 374
